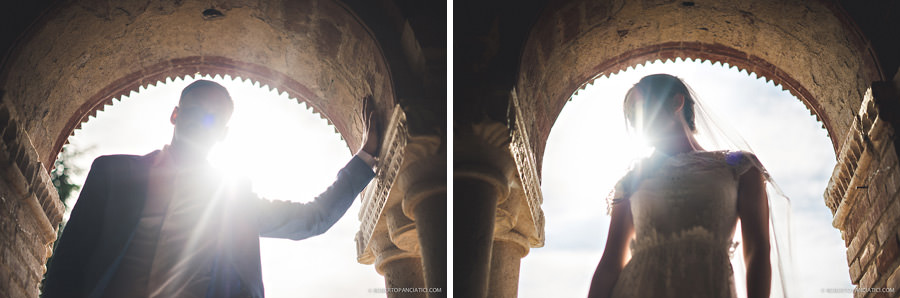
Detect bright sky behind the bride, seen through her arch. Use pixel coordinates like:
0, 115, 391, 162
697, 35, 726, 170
519, 61, 853, 298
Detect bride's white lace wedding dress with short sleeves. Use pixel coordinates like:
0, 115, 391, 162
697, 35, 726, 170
611, 150, 762, 298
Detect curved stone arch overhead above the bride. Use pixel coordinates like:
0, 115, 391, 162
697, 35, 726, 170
516, 1, 882, 173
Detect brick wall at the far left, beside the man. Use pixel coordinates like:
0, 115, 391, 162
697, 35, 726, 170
0, 100, 64, 297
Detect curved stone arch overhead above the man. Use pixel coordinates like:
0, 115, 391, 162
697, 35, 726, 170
0, 0, 396, 169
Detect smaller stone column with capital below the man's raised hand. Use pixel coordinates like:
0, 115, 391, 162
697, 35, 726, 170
371, 231, 426, 298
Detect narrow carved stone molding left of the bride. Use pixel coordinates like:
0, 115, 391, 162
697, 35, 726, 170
509, 89, 544, 247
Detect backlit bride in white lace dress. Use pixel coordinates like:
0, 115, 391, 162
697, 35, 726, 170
589, 74, 778, 298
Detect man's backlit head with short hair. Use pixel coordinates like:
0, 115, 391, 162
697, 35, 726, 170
170, 80, 234, 158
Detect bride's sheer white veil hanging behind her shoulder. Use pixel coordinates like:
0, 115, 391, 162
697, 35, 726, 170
612, 74, 797, 298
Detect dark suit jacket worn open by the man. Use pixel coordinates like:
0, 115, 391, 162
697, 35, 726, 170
43, 150, 374, 298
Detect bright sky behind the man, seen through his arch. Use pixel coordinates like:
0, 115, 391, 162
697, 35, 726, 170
67, 77, 384, 298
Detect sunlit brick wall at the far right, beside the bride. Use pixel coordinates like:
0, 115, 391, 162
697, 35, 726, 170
825, 83, 900, 297
